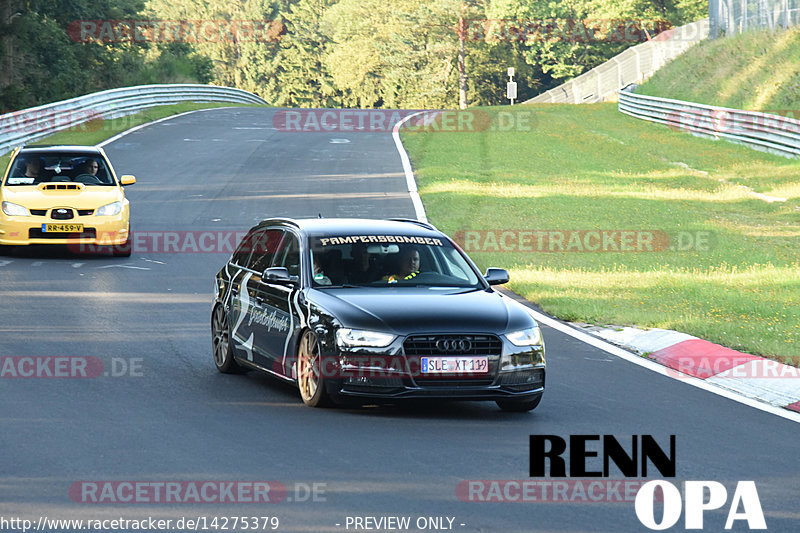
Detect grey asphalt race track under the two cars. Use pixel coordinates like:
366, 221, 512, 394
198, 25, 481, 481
0, 108, 800, 533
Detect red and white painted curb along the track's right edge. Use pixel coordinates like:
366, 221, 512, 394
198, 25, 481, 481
573, 324, 800, 412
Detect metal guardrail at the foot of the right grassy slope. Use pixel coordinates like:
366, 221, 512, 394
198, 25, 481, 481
619, 85, 800, 157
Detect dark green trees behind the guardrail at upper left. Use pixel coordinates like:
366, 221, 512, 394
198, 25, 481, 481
0, 0, 210, 110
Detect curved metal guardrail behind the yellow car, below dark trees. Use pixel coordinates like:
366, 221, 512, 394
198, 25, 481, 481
0, 84, 267, 154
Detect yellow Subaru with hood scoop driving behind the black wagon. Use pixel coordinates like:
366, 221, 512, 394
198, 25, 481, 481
0, 146, 136, 256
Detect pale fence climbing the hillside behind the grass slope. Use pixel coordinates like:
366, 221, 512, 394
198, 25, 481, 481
523, 19, 708, 104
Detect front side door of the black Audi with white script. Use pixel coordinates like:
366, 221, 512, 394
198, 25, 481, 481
253, 230, 300, 376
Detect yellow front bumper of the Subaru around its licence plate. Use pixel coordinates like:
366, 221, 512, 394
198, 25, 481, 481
0, 211, 129, 246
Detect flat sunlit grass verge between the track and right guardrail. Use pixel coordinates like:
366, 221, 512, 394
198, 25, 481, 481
403, 104, 800, 363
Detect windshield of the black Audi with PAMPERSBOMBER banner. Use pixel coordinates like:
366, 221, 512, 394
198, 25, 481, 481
310, 235, 483, 289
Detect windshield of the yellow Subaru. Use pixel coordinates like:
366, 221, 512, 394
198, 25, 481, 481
4, 152, 115, 186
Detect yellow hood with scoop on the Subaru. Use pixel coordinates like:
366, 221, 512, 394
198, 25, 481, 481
0, 185, 123, 209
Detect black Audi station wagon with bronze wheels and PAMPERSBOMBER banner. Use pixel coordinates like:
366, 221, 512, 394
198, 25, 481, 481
211, 218, 545, 411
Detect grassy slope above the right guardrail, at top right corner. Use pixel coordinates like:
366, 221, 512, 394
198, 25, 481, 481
638, 28, 800, 111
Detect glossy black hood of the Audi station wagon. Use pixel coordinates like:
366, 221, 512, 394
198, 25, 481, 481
309, 287, 535, 335
